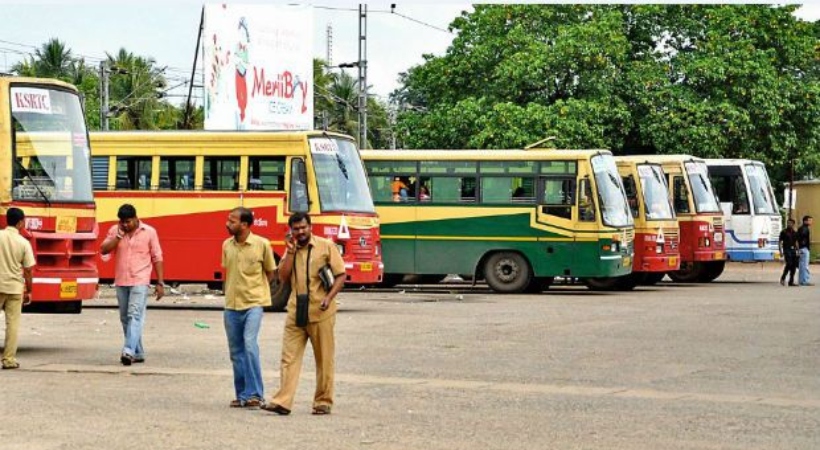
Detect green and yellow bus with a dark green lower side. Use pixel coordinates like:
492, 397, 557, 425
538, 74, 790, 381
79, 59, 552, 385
362, 150, 633, 293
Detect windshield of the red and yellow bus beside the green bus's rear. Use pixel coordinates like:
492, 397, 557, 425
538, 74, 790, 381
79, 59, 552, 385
310, 137, 376, 213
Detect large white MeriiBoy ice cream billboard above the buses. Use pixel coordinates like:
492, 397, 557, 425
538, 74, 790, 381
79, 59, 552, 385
202, 4, 313, 130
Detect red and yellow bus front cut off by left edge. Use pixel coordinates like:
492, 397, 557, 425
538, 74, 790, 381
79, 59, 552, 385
0, 76, 99, 313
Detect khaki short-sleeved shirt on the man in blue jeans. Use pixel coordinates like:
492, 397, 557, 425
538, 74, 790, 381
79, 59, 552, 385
222, 233, 276, 311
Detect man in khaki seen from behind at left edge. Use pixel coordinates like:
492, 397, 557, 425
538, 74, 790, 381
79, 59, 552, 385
0, 208, 34, 369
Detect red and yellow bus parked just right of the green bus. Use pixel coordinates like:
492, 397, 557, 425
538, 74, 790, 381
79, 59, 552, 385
587, 156, 680, 290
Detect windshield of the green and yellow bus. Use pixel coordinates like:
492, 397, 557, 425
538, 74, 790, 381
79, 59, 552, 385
592, 155, 633, 227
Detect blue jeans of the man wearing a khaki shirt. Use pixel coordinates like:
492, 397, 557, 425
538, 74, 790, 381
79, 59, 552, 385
224, 306, 265, 401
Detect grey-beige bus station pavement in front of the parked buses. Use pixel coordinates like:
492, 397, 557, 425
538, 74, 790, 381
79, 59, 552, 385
0, 263, 820, 450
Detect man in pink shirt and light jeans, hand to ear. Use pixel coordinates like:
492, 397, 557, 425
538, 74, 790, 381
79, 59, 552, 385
100, 203, 165, 366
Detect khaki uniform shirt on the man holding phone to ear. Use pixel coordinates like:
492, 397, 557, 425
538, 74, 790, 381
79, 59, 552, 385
288, 235, 345, 322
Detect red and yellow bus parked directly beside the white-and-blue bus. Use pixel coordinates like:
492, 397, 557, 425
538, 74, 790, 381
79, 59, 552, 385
640, 155, 726, 282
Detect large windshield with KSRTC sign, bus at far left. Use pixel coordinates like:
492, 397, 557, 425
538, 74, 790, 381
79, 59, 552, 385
10, 84, 94, 204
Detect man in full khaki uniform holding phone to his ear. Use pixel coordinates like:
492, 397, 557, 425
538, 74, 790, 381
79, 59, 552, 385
263, 213, 345, 415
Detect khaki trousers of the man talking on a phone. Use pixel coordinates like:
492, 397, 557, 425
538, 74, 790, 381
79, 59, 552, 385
272, 315, 336, 409
